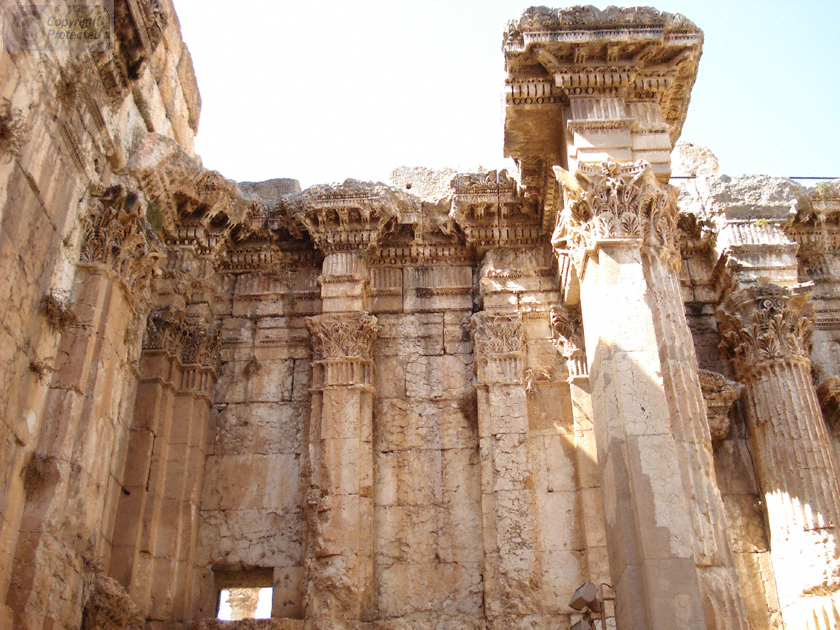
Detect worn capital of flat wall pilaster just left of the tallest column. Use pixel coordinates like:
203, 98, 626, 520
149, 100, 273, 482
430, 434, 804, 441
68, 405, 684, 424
470, 312, 525, 385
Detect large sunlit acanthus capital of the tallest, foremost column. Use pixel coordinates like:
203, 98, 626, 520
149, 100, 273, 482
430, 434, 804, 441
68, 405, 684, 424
551, 160, 680, 276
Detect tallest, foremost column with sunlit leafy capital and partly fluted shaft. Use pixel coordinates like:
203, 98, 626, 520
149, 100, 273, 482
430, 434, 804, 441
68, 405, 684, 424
554, 160, 747, 628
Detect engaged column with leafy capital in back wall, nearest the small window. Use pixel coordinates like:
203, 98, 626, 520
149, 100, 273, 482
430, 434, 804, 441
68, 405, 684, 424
306, 312, 378, 629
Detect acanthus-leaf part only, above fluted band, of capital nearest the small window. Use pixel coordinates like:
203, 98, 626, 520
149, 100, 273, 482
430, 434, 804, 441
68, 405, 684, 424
306, 312, 379, 361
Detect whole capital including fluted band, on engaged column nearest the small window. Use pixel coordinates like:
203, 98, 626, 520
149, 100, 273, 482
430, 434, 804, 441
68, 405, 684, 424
306, 313, 379, 387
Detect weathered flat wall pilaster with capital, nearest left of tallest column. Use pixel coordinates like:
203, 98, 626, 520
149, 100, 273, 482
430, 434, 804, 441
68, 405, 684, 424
470, 311, 542, 629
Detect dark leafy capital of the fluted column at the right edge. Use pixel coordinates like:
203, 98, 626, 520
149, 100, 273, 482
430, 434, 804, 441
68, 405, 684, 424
717, 284, 814, 381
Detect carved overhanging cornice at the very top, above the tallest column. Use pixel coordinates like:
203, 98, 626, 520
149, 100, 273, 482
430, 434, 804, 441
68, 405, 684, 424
503, 6, 703, 141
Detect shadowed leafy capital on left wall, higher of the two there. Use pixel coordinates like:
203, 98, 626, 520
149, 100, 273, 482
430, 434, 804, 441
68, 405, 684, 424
79, 185, 164, 301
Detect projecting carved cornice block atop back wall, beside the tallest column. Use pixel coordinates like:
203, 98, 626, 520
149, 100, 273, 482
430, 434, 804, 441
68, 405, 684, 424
450, 170, 542, 249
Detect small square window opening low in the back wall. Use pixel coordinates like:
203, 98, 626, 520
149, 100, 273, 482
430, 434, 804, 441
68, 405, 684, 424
214, 569, 274, 621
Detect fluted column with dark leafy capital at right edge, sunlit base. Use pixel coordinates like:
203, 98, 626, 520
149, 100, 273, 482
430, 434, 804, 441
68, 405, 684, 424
718, 284, 840, 629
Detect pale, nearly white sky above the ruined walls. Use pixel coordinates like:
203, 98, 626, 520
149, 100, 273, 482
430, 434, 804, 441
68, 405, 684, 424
174, 0, 840, 187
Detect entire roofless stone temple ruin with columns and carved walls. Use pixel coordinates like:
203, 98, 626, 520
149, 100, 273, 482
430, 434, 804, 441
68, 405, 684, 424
0, 0, 840, 630
